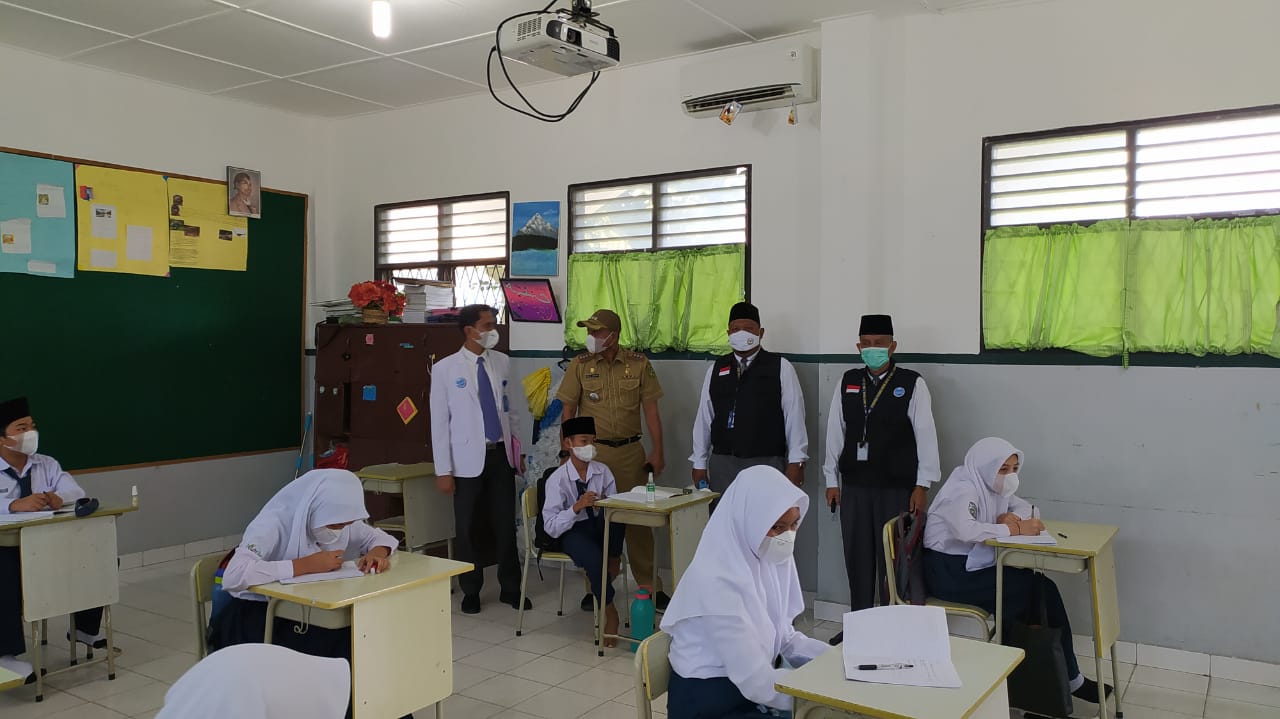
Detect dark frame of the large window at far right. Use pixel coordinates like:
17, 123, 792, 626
978, 104, 1280, 358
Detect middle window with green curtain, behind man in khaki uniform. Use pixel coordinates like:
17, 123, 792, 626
564, 165, 751, 352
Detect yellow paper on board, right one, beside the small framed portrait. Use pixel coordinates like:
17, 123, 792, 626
169, 178, 248, 273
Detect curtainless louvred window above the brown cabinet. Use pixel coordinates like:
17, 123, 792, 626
374, 193, 511, 313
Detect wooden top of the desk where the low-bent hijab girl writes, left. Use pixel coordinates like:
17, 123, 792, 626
250, 551, 472, 609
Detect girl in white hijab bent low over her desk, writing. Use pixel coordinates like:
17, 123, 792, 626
209, 470, 397, 659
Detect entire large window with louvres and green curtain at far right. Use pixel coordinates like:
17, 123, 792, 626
982, 106, 1280, 357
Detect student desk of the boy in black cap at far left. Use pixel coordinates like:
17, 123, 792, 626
0, 505, 137, 701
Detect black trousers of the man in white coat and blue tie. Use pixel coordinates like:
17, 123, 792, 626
453, 445, 520, 596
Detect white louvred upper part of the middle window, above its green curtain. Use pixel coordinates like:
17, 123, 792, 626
570, 165, 751, 252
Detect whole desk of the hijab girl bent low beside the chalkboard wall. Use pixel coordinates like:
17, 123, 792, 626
250, 551, 471, 719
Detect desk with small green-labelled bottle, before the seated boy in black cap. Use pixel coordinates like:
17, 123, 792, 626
595, 487, 719, 656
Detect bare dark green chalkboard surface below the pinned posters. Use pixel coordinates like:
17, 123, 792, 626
0, 191, 307, 470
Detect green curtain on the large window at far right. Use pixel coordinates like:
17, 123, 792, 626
982, 217, 1280, 357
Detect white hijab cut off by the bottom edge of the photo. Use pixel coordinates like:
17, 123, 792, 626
156, 644, 351, 719
